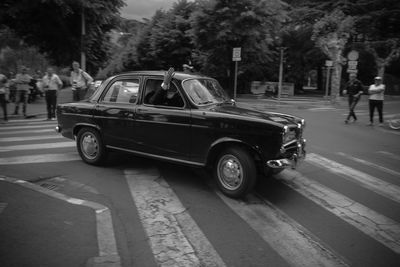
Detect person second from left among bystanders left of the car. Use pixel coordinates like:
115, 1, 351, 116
14, 66, 32, 117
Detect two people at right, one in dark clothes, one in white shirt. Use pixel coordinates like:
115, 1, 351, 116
343, 73, 385, 126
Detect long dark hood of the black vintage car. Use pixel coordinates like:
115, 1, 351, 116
210, 105, 301, 125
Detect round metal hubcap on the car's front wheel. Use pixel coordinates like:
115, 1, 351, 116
217, 155, 243, 190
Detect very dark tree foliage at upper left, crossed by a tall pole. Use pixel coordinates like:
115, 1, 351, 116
0, 0, 124, 73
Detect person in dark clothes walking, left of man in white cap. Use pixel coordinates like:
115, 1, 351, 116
343, 73, 364, 124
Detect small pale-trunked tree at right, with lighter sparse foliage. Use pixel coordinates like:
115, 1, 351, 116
312, 10, 354, 102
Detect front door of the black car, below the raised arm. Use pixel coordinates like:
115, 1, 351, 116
136, 77, 191, 161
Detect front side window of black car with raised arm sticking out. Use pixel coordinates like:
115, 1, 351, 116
143, 79, 185, 108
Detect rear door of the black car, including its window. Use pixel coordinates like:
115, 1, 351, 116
94, 76, 140, 150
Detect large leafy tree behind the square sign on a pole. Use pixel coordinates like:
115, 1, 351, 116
191, 0, 287, 92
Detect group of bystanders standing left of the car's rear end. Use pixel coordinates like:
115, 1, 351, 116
0, 61, 93, 122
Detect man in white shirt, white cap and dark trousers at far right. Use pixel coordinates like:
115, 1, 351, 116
368, 76, 385, 126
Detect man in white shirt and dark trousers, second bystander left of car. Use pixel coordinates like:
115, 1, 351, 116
42, 67, 62, 120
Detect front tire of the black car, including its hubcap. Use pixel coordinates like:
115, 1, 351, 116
213, 147, 257, 198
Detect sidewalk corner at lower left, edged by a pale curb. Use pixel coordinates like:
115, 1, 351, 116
0, 176, 98, 267
